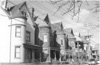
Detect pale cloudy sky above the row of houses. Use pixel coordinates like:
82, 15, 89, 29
6, 0, 100, 44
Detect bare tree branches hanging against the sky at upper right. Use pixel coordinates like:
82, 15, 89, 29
50, 0, 100, 28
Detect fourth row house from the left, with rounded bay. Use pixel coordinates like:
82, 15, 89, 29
64, 28, 76, 60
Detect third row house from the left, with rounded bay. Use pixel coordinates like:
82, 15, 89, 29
51, 22, 66, 61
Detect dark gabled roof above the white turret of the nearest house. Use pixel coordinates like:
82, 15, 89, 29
10, 2, 26, 18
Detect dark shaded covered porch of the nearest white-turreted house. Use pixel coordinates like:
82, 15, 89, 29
23, 44, 42, 63
